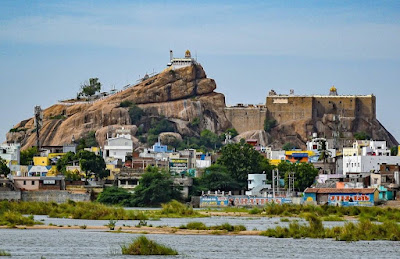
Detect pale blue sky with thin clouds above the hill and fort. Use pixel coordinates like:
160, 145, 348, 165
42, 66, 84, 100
0, 0, 400, 141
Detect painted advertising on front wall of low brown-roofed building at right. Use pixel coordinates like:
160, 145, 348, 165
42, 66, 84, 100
328, 193, 374, 206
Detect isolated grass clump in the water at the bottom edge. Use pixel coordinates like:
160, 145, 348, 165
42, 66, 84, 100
121, 236, 178, 255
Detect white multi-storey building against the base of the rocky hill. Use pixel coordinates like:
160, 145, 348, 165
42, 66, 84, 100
103, 134, 133, 162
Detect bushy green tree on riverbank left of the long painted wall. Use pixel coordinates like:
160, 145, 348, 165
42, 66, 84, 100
133, 166, 181, 207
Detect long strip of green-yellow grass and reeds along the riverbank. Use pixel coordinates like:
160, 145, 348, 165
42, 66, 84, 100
0, 201, 400, 244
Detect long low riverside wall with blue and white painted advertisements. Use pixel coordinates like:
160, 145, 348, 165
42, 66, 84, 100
200, 196, 292, 207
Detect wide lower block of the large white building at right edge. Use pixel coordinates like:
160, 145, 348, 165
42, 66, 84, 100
343, 156, 400, 175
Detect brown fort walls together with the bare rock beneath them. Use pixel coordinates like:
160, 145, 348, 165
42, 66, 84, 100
225, 86, 398, 147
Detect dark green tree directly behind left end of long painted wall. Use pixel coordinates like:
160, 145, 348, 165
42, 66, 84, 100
199, 164, 241, 191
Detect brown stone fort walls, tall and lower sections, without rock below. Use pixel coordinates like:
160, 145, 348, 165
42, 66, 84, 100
225, 95, 376, 133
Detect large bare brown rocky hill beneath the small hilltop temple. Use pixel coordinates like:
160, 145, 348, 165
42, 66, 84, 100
7, 65, 231, 149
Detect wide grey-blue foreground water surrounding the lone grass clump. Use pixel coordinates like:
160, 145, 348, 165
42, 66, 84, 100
0, 229, 400, 259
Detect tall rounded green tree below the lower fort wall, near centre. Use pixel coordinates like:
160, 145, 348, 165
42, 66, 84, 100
217, 142, 263, 187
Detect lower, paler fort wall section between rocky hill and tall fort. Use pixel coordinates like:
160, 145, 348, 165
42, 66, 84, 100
225, 107, 267, 134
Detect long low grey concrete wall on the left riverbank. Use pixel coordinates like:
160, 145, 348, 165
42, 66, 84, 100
21, 191, 90, 203
